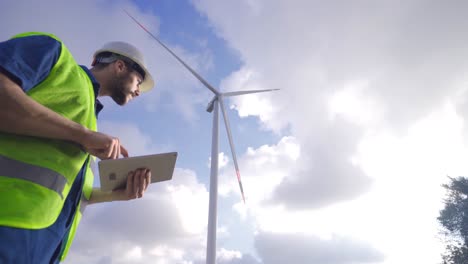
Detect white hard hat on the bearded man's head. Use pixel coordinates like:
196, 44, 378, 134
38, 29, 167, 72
93, 41, 154, 92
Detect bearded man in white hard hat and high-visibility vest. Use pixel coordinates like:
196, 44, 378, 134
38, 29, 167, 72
0, 32, 154, 264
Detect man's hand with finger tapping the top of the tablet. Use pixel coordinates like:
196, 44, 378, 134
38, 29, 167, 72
80, 131, 128, 160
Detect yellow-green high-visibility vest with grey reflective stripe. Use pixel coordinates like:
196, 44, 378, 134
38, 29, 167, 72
0, 32, 97, 260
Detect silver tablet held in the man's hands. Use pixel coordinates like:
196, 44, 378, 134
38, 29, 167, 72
98, 152, 177, 192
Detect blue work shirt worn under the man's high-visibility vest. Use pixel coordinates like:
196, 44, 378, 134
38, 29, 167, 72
0, 35, 103, 264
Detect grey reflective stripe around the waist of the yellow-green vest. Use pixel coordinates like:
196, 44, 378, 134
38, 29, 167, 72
0, 155, 67, 196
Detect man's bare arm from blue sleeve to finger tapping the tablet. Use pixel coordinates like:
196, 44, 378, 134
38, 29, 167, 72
0, 71, 128, 159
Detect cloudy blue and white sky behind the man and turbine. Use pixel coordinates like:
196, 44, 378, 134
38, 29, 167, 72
0, 0, 468, 264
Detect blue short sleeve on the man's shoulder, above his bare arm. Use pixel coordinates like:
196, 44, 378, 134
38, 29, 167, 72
0, 35, 61, 92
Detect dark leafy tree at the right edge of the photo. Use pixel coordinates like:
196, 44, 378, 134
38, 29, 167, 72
437, 177, 468, 264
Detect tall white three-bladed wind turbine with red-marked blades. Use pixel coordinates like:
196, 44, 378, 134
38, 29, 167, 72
124, 10, 279, 264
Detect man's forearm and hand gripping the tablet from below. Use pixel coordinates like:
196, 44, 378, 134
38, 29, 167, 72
89, 169, 151, 204
